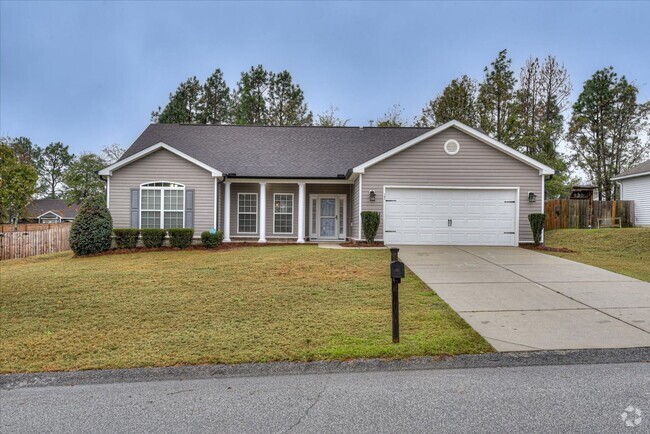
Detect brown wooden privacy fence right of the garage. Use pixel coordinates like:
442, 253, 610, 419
544, 199, 634, 231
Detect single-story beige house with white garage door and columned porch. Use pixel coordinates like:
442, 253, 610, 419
99, 121, 553, 246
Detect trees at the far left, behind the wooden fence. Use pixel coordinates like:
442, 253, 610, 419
0, 137, 124, 223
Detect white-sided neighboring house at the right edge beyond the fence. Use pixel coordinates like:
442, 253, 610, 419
612, 160, 650, 226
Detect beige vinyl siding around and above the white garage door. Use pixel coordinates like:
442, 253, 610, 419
361, 128, 544, 242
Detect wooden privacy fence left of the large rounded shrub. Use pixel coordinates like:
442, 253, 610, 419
0, 223, 72, 260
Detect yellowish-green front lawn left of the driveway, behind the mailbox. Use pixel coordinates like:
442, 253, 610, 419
0, 246, 492, 373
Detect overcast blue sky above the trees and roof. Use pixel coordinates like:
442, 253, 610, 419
0, 1, 650, 153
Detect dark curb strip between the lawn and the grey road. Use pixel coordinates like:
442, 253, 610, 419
0, 347, 650, 390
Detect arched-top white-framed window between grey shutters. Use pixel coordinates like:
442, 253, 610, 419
140, 181, 185, 229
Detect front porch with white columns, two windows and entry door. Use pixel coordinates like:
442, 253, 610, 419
217, 179, 354, 243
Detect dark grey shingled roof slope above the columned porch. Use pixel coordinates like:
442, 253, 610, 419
122, 124, 429, 178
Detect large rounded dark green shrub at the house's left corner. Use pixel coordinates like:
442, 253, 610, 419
70, 197, 113, 256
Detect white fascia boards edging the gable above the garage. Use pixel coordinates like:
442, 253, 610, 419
352, 121, 555, 175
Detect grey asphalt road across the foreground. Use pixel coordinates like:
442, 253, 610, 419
0, 363, 650, 433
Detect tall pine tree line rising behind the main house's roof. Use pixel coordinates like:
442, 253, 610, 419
152, 57, 650, 200
